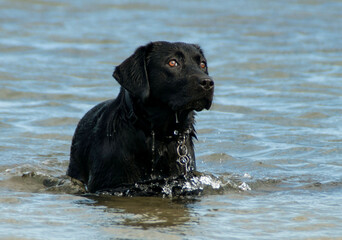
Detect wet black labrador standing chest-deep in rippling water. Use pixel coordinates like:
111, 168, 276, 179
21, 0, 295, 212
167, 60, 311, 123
67, 42, 214, 192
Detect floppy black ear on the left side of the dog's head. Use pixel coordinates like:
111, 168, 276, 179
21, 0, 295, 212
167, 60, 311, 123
113, 44, 151, 101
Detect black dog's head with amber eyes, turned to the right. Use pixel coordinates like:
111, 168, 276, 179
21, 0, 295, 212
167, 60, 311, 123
113, 42, 214, 111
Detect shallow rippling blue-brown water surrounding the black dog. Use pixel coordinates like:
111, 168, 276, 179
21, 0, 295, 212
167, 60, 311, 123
0, 0, 342, 239
